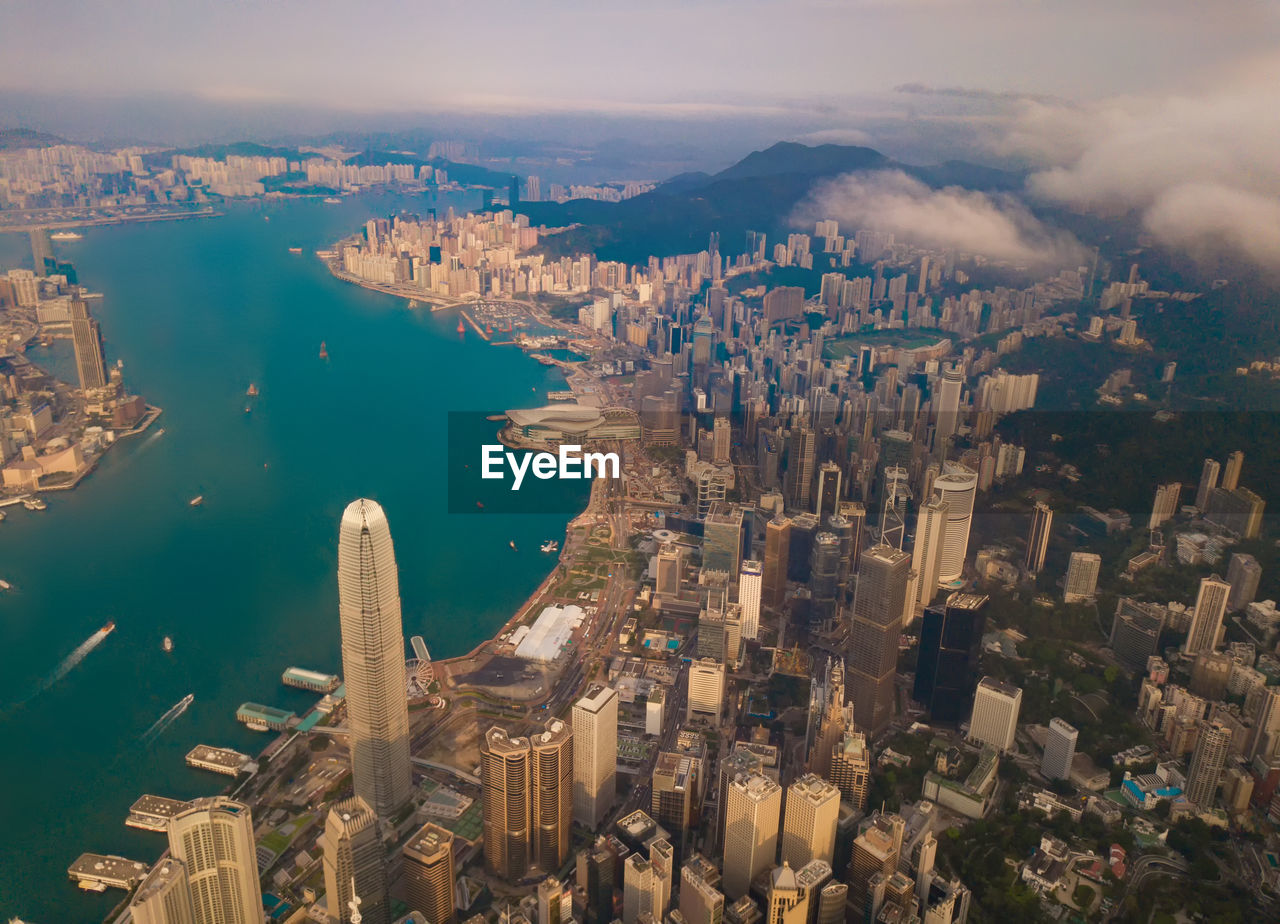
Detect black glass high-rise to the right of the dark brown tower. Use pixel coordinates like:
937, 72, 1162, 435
911, 593, 987, 723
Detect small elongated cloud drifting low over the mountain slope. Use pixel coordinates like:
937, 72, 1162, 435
792, 170, 1082, 265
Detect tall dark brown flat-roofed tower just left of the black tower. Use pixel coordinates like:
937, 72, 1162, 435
846, 545, 911, 737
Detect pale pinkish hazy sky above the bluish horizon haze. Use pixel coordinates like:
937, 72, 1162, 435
0, 0, 1280, 114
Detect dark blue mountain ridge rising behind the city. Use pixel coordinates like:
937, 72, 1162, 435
506, 142, 1023, 262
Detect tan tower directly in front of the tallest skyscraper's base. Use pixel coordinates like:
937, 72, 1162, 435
319, 796, 390, 924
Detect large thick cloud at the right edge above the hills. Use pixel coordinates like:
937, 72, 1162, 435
992, 59, 1280, 269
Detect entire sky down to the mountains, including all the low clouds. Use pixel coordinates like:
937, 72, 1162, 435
0, 0, 1280, 269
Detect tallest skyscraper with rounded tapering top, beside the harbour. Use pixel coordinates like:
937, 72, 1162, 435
338, 499, 412, 818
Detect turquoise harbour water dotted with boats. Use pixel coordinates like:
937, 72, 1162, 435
0, 190, 586, 924
